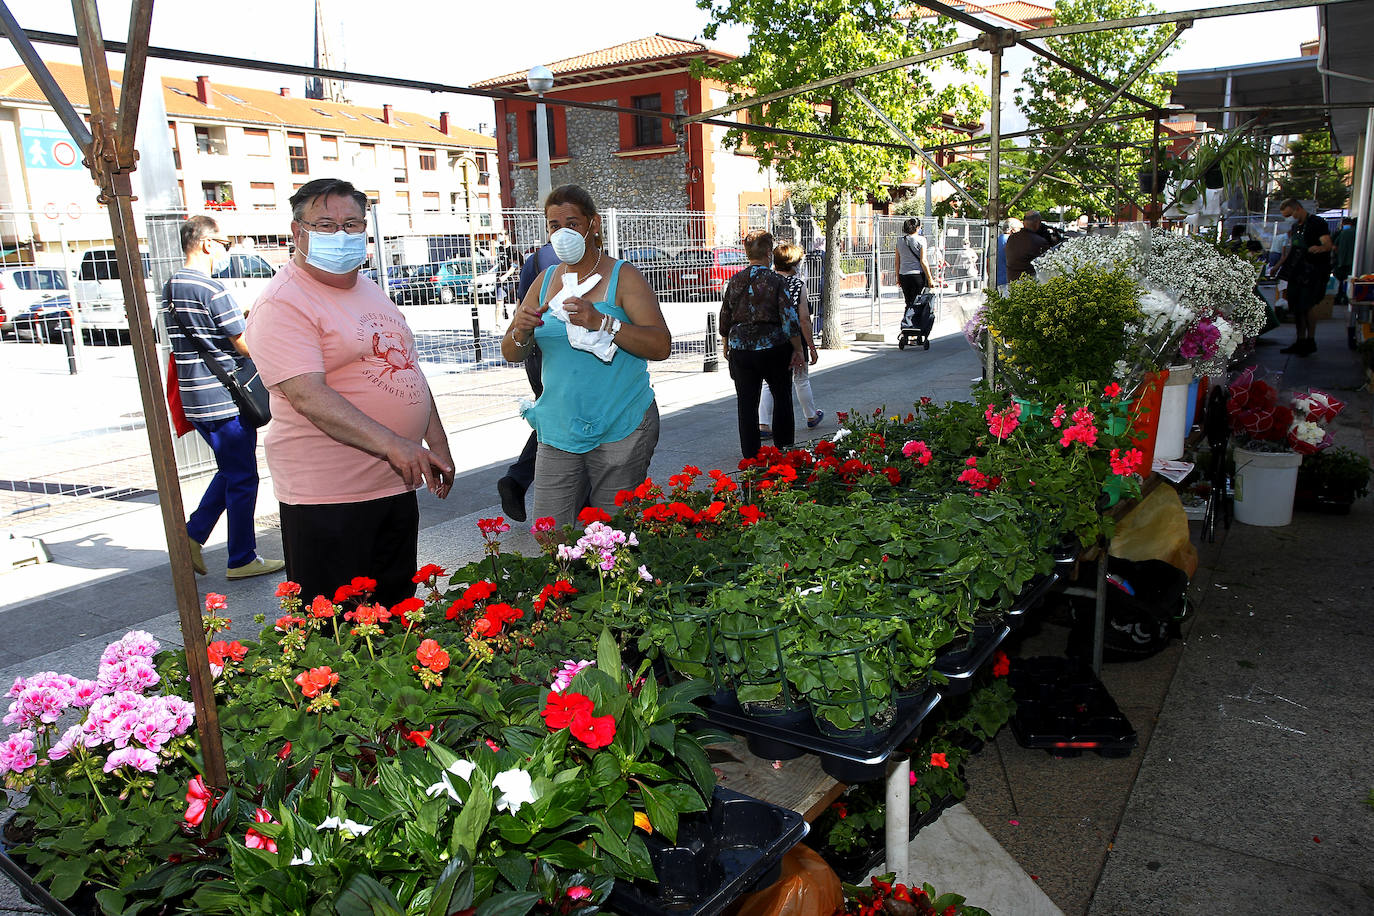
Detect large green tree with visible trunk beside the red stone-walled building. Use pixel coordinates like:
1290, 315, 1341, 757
697, 0, 987, 347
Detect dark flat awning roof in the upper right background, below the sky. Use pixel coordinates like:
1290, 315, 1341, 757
1169, 55, 1324, 135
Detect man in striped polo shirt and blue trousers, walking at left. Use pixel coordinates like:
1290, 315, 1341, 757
162, 216, 286, 580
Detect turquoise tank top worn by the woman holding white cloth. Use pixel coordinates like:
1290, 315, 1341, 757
523, 261, 654, 455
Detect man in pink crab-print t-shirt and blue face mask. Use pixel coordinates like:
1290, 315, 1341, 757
247, 179, 453, 607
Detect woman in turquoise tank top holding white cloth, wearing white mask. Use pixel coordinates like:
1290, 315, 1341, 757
502, 184, 672, 526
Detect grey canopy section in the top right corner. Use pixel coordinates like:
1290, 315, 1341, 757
1316, 0, 1374, 155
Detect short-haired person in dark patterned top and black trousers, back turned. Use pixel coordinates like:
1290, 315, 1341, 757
720, 229, 805, 459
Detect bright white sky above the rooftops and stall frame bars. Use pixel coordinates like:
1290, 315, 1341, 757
0, 0, 1316, 128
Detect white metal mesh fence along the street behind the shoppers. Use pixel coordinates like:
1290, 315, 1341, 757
0, 203, 985, 530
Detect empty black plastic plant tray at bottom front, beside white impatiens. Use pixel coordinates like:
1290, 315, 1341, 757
607, 786, 809, 916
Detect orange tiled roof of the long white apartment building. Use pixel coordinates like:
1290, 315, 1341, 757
0, 62, 496, 150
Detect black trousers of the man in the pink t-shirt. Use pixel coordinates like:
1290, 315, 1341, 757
282, 492, 420, 607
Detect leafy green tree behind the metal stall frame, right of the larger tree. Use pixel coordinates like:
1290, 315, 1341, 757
1003, 0, 1173, 214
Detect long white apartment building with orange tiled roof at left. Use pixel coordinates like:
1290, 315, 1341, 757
0, 63, 500, 262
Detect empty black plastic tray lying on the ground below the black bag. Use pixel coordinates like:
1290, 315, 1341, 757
1007, 656, 1139, 757
